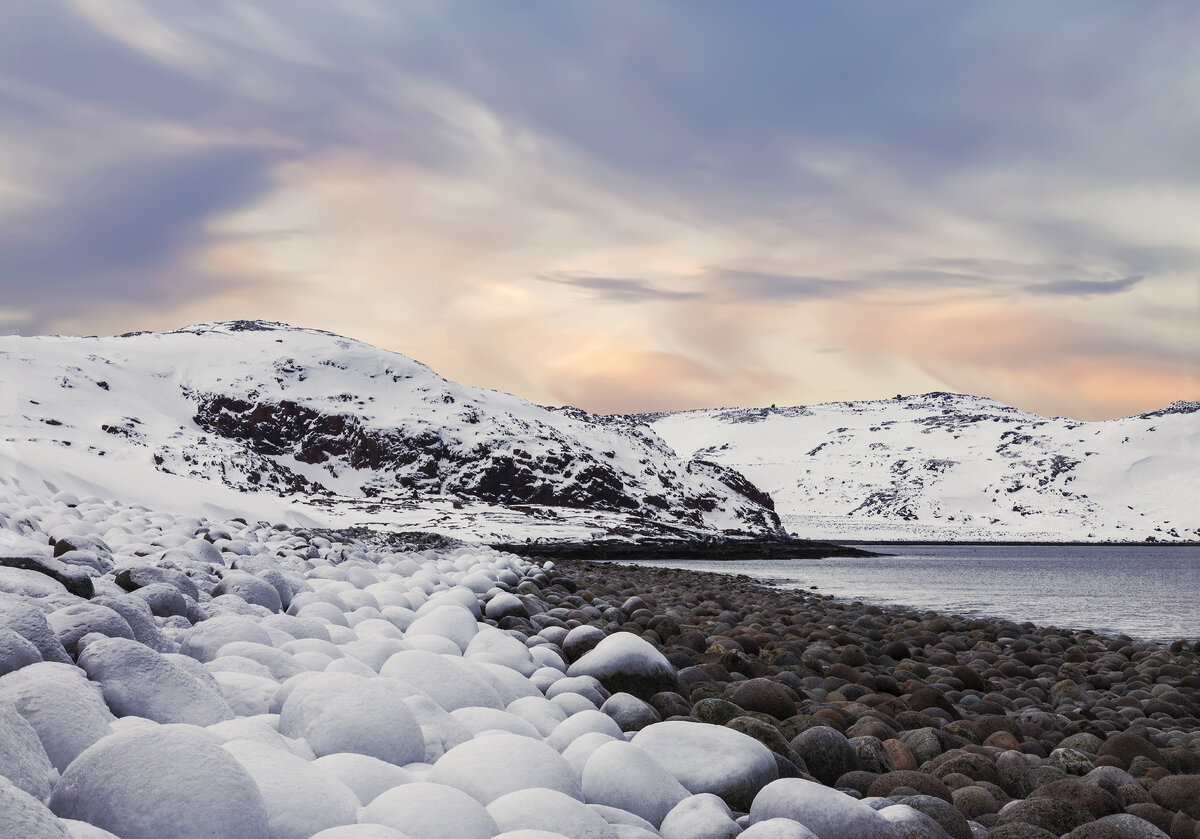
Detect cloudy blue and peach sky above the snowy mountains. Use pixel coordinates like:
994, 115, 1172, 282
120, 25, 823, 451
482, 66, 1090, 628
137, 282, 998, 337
0, 0, 1200, 419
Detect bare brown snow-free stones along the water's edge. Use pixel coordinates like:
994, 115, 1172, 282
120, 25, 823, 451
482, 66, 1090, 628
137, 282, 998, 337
535, 559, 1200, 839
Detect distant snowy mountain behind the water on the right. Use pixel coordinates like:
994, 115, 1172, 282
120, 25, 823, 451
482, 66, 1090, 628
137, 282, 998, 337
632, 392, 1200, 541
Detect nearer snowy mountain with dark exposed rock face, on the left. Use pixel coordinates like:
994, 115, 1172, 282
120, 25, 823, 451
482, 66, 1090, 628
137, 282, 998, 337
0, 322, 778, 539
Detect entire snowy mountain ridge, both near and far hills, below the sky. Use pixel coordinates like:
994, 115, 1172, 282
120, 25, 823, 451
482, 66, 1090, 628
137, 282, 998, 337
0, 320, 1200, 543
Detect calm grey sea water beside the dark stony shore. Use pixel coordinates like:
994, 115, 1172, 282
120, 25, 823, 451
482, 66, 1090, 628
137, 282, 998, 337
628, 545, 1200, 640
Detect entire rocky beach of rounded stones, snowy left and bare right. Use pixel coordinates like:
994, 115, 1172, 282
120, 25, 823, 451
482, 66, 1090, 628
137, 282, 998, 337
0, 493, 1200, 839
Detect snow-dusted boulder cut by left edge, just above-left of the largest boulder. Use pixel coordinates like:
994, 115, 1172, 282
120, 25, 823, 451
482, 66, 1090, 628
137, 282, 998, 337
0, 661, 114, 772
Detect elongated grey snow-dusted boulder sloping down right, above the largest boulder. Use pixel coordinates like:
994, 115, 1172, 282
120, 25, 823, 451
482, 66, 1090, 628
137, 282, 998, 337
79, 639, 233, 725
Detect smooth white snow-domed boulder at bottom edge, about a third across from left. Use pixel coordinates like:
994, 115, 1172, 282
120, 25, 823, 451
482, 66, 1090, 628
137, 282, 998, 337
359, 781, 500, 839
